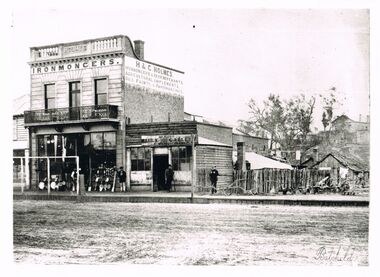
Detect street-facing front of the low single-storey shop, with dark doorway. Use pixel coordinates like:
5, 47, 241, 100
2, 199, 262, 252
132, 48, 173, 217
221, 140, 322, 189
127, 134, 196, 191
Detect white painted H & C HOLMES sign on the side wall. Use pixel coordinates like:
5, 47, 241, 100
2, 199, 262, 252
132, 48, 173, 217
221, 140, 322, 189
125, 57, 184, 96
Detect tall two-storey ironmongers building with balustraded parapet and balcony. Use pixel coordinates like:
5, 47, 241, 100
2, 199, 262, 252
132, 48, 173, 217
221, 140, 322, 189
25, 35, 183, 188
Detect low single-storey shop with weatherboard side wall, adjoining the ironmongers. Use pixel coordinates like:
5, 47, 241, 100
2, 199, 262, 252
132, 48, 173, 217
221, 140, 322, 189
126, 121, 232, 192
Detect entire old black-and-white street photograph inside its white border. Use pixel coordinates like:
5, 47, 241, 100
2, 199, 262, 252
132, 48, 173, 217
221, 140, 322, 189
6, 5, 373, 267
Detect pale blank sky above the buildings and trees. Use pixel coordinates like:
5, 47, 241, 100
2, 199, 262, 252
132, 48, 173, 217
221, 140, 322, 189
12, 9, 369, 128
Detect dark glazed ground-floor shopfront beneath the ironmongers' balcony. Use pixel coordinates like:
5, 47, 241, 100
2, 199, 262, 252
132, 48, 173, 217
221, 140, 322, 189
35, 132, 116, 187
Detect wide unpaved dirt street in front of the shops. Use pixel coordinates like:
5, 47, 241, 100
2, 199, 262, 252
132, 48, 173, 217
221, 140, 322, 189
14, 200, 368, 265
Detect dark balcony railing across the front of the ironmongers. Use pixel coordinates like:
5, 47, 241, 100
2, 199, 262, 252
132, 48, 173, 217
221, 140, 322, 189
24, 105, 117, 124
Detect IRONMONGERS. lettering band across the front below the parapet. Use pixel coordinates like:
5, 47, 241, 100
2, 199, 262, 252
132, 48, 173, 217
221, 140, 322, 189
31, 58, 122, 74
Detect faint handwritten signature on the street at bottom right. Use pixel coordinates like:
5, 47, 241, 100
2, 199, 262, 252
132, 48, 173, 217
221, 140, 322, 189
314, 245, 355, 262
